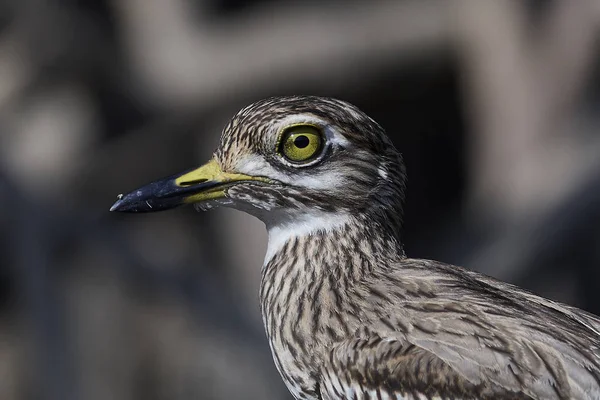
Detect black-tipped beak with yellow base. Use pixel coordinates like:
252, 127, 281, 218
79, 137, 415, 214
110, 158, 268, 212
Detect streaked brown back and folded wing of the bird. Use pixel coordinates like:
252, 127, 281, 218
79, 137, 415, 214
322, 260, 600, 400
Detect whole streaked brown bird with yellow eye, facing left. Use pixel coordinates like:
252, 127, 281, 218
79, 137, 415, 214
111, 95, 600, 400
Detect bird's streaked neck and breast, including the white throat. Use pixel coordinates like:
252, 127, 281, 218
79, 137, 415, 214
260, 206, 404, 387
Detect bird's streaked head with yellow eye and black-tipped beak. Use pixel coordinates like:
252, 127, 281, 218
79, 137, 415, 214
111, 96, 404, 230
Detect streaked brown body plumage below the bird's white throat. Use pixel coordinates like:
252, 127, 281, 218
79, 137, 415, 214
261, 220, 600, 399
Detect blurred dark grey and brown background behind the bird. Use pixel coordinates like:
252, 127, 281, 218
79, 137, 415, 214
0, 0, 600, 400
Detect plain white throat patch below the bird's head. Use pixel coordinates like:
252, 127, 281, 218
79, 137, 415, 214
263, 210, 352, 266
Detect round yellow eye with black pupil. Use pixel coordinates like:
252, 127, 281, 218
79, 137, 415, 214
279, 125, 323, 163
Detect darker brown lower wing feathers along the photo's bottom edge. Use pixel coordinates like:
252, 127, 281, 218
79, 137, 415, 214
319, 336, 536, 400
